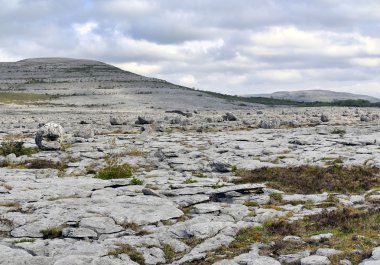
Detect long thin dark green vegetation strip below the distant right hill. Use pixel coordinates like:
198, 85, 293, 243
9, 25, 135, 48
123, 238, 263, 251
200, 90, 380, 108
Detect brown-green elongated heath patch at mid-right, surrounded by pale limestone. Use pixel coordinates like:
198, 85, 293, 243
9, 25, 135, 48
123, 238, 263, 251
234, 164, 380, 194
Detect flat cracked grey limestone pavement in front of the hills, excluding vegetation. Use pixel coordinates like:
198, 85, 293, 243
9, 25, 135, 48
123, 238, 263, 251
0, 103, 380, 265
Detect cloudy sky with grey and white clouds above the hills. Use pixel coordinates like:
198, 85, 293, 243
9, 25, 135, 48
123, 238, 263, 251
0, 0, 380, 97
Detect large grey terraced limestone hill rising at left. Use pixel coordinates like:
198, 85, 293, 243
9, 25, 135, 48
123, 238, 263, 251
0, 58, 254, 111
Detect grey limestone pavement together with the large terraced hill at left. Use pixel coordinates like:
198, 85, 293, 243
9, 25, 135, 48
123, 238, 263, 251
0, 59, 380, 265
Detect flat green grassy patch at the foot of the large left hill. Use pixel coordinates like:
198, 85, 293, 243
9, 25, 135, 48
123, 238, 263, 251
0, 92, 58, 104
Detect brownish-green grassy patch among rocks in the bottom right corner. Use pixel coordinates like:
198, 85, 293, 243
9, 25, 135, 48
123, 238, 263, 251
199, 208, 380, 265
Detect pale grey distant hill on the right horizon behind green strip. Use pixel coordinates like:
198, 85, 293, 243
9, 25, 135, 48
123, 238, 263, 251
245, 90, 380, 102
